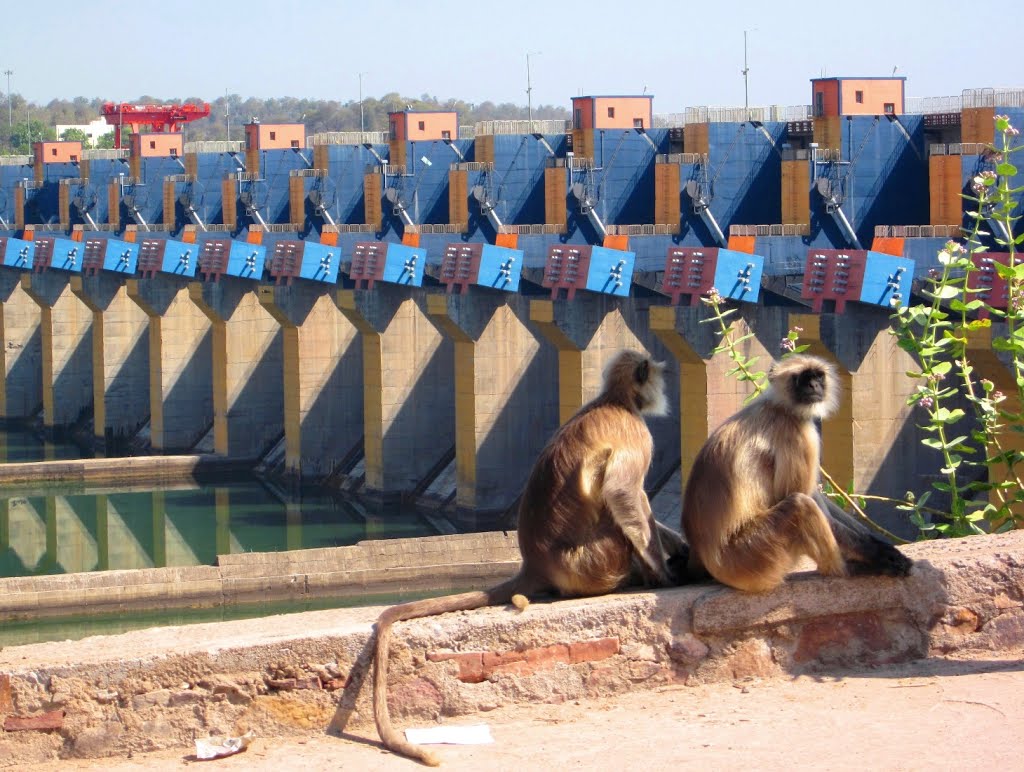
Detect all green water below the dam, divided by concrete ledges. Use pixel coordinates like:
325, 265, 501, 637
0, 431, 460, 646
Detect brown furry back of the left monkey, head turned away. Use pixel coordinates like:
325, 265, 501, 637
517, 401, 653, 595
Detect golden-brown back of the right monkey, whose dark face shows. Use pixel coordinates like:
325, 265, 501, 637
682, 397, 820, 555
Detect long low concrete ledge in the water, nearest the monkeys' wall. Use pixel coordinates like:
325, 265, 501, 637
0, 531, 519, 621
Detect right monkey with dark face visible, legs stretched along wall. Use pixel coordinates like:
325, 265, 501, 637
682, 355, 911, 592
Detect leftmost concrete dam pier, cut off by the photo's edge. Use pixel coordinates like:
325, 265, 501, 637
0, 270, 43, 419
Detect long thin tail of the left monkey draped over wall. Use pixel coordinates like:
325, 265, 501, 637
374, 575, 522, 767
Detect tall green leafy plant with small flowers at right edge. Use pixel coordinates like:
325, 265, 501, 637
892, 116, 1024, 538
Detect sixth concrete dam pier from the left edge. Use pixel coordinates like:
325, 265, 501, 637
258, 282, 364, 477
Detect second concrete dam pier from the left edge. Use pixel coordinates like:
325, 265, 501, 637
22, 271, 92, 431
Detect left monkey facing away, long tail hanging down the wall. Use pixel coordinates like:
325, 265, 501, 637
374, 350, 686, 766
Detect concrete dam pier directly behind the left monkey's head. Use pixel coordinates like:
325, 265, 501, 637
529, 293, 679, 487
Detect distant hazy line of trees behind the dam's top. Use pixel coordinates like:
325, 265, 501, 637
0, 92, 570, 155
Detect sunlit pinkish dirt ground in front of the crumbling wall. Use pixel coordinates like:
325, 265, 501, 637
25, 650, 1024, 772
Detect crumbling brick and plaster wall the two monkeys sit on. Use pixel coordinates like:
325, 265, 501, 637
0, 531, 1024, 766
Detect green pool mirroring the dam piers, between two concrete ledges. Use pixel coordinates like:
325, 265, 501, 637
0, 481, 435, 577
